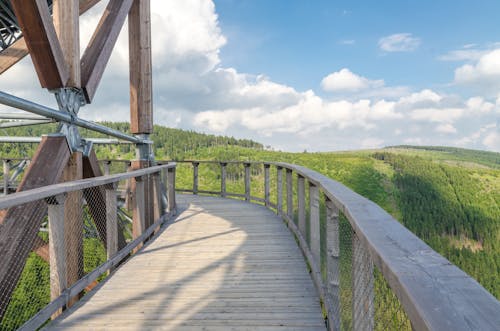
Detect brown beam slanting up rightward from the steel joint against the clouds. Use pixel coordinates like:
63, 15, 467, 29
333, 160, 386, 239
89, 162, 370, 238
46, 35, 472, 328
81, 0, 133, 103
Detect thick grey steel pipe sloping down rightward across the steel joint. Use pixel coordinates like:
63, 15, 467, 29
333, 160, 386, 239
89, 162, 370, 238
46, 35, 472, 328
0, 91, 152, 144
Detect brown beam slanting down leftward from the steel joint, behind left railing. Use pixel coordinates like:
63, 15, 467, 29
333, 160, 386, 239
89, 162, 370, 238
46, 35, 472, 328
0, 136, 71, 320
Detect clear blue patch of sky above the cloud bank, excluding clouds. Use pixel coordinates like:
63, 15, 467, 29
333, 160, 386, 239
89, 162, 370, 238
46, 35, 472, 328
215, 0, 500, 90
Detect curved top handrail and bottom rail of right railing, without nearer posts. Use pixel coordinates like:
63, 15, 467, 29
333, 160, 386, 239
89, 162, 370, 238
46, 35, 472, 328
176, 160, 500, 330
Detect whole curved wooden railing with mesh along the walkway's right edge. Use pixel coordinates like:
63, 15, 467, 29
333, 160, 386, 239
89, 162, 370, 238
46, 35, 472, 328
174, 161, 500, 330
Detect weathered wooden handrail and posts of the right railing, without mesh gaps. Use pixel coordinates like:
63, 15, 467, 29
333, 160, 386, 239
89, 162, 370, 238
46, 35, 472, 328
176, 160, 500, 330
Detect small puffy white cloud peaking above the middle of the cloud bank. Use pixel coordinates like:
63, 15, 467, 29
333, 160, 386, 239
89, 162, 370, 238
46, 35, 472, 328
321, 68, 384, 92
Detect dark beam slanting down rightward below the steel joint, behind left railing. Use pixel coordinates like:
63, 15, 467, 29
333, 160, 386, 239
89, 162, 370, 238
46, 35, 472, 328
83, 150, 126, 249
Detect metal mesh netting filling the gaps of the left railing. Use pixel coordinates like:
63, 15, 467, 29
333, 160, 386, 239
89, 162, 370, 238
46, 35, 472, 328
0, 181, 132, 331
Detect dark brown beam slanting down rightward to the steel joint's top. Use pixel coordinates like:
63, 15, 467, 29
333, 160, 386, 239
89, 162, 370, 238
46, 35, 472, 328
11, 0, 69, 89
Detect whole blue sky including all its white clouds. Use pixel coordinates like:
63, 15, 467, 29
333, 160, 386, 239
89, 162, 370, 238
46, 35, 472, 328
0, 0, 500, 152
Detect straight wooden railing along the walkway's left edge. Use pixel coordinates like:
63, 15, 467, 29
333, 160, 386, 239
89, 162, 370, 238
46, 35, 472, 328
0, 163, 176, 330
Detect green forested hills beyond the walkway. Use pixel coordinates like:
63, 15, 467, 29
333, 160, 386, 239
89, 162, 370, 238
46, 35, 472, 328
0, 123, 500, 329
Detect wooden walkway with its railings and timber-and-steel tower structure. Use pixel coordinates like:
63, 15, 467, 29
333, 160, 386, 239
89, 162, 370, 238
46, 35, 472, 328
0, 0, 500, 330
